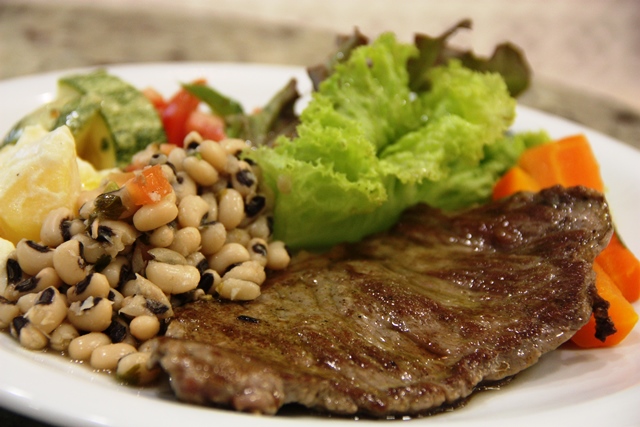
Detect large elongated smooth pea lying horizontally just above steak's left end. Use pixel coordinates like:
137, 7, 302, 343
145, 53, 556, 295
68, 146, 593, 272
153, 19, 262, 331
146, 260, 200, 294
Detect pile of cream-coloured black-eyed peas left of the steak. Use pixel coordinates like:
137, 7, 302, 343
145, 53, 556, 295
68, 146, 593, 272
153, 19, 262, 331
0, 133, 290, 384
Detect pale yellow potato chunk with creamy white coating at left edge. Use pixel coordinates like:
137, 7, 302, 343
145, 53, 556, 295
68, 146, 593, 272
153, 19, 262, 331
0, 126, 81, 244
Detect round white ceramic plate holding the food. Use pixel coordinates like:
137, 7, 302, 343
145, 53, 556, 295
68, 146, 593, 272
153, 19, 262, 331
0, 63, 640, 427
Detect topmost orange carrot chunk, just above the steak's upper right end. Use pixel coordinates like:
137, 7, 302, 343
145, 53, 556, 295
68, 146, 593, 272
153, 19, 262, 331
518, 134, 604, 191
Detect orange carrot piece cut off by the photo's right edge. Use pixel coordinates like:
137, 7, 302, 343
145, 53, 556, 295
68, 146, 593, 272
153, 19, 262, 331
596, 233, 640, 302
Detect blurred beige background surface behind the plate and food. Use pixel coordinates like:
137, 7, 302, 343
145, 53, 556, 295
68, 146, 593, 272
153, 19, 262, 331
0, 0, 640, 143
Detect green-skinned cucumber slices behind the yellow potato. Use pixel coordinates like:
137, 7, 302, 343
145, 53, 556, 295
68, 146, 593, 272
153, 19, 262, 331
2, 70, 166, 169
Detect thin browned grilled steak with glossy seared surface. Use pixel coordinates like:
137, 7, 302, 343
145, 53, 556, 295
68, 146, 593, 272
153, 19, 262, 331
153, 187, 612, 417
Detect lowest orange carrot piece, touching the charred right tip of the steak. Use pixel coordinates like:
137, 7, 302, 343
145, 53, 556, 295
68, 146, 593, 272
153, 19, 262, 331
572, 263, 638, 348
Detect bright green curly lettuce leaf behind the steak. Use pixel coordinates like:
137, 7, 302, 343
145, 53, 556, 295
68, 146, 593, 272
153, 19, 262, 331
248, 33, 528, 249
